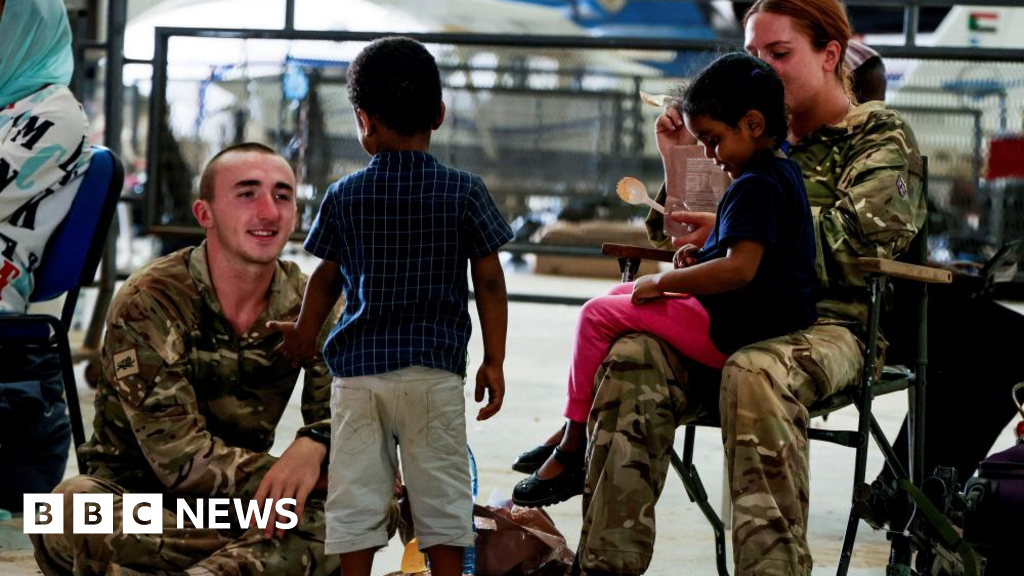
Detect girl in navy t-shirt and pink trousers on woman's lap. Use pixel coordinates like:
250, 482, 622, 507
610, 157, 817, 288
512, 53, 817, 506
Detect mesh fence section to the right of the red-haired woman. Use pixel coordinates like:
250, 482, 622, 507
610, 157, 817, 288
886, 58, 1024, 260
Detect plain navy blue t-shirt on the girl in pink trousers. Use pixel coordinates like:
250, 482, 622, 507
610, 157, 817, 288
697, 157, 817, 354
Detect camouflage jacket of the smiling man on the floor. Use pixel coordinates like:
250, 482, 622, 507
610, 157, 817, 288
82, 244, 331, 498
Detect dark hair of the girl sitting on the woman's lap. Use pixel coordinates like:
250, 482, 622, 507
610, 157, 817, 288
680, 52, 788, 147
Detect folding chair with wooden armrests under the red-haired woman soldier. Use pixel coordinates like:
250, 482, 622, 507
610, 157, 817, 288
601, 159, 952, 576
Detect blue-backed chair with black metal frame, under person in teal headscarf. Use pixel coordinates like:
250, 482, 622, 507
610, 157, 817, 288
0, 146, 124, 470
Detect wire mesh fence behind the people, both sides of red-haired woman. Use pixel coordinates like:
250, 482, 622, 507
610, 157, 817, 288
147, 30, 1024, 268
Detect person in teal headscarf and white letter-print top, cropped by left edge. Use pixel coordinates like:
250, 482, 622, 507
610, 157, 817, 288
0, 0, 90, 509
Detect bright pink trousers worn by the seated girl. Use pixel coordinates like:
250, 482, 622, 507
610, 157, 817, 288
565, 282, 728, 422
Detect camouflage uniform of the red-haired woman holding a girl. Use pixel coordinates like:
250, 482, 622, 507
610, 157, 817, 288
580, 101, 926, 576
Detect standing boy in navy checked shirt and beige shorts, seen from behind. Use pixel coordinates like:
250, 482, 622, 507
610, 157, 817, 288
278, 38, 512, 576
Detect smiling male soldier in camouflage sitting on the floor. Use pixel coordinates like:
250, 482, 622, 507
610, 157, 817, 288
32, 143, 346, 575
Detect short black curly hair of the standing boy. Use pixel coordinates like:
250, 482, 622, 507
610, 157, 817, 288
347, 36, 441, 136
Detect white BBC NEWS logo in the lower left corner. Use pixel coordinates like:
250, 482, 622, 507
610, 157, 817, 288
24, 494, 299, 534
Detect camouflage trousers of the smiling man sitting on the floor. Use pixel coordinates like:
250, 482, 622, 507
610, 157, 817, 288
31, 476, 339, 576
